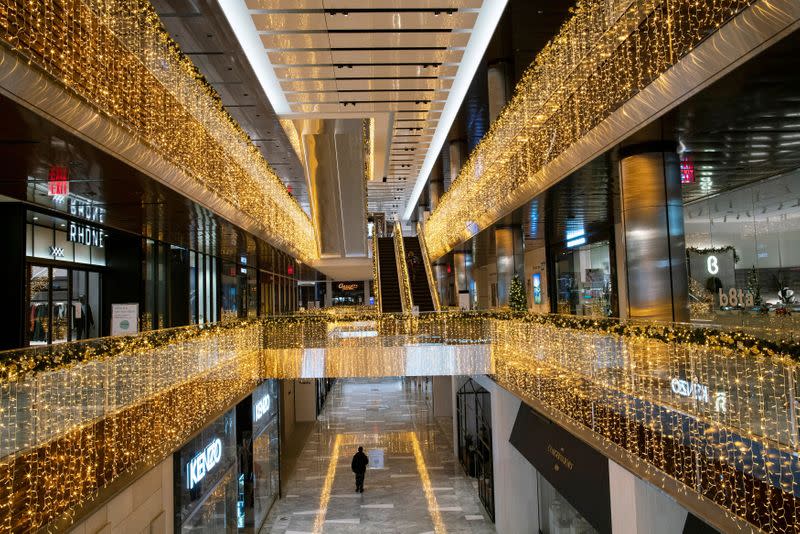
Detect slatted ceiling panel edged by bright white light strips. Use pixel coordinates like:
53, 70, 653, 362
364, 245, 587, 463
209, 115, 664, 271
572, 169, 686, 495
218, 0, 506, 218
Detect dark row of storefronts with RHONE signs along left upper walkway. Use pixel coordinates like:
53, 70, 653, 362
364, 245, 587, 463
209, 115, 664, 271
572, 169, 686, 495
0, 93, 316, 349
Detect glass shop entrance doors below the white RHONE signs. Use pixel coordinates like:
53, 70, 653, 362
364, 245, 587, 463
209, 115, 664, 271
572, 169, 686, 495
26, 264, 102, 345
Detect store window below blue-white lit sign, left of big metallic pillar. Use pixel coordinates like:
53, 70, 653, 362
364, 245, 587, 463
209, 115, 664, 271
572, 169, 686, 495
555, 241, 613, 317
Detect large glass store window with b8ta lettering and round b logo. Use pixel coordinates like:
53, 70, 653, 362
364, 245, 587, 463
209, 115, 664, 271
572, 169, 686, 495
684, 171, 800, 329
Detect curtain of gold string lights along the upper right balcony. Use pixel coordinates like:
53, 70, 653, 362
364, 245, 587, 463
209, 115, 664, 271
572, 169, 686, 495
425, 0, 755, 260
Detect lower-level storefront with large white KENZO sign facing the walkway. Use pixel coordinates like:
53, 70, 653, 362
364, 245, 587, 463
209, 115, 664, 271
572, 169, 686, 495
174, 409, 241, 534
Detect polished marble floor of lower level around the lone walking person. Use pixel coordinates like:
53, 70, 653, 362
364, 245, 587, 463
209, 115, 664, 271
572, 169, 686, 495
262, 378, 495, 534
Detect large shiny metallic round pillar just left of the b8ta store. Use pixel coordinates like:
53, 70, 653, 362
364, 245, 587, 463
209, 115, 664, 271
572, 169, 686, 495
620, 141, 689, 322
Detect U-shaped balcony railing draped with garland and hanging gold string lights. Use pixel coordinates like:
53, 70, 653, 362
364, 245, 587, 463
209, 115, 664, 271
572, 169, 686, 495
0, 313, 800, 532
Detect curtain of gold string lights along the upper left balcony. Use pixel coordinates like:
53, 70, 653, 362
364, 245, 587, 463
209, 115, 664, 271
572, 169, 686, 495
0, 0, 318, 262
